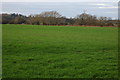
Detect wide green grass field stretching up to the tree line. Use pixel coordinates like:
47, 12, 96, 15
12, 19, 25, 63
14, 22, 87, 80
2, 24, 118, 78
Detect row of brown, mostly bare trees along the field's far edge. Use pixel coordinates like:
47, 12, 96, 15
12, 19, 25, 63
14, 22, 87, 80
0, 11, 118, 26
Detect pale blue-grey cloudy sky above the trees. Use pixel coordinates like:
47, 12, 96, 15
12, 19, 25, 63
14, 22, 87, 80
2, 2, 118, 19
